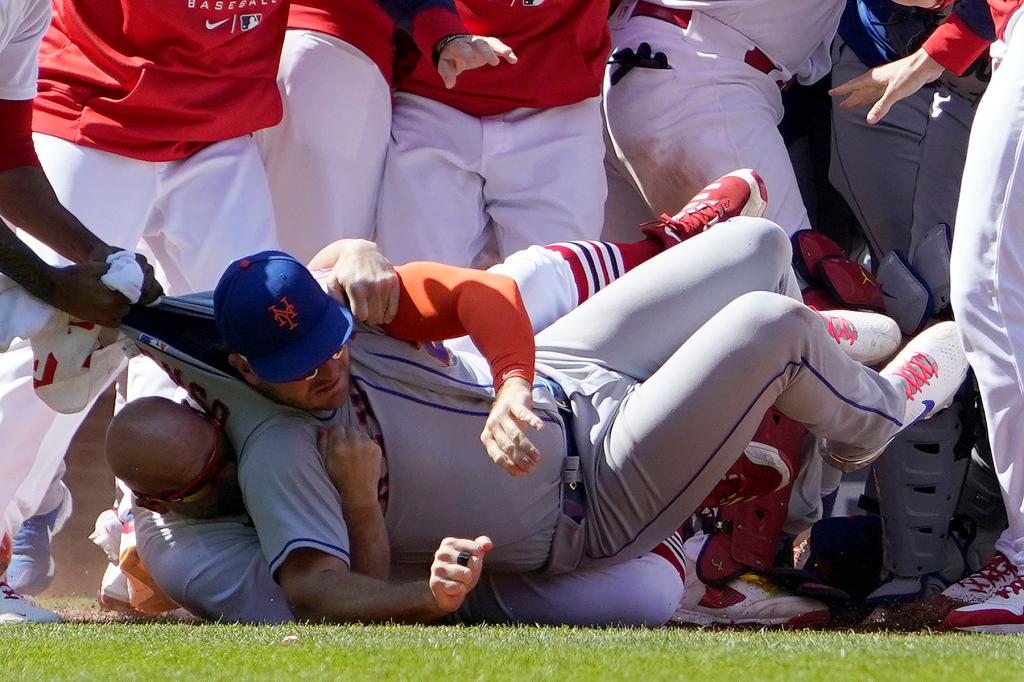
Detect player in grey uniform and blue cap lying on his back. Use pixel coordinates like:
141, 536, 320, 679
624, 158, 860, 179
101, 189, 966, 621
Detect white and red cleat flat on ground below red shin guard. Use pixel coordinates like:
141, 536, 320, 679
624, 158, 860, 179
672, 535, 828, 628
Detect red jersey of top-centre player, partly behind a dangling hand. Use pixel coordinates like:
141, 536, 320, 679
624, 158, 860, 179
395, 0, 611, 116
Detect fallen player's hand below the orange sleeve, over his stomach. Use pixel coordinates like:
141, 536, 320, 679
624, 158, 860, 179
480, 377, 544, 476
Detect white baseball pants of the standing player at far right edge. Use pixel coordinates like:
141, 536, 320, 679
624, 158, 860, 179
950, 10, 1024, 566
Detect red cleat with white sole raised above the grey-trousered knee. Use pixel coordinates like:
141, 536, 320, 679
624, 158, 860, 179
640, 168, 768, 248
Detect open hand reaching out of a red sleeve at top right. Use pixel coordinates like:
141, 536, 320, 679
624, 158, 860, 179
828, 49, 944, 124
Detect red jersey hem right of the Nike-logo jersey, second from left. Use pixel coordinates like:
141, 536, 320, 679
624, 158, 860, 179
288, 0, 394, 83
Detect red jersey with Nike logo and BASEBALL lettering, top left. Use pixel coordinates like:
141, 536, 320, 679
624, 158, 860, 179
34, 0, 288, 161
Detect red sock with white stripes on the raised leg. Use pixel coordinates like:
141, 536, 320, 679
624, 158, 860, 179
545, 239, 665, 303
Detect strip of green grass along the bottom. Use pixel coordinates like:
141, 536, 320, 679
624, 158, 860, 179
0, 623, 1024, 682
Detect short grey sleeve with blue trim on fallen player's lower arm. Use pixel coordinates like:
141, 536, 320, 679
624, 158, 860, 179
239, 416, 351, 577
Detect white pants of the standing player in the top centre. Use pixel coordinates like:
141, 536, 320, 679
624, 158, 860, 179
377, 92, 607, 266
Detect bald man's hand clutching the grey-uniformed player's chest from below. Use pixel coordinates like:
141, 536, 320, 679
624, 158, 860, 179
316, 426, 381, 509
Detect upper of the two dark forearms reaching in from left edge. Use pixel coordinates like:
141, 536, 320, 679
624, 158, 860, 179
0, 166, 112, 263
